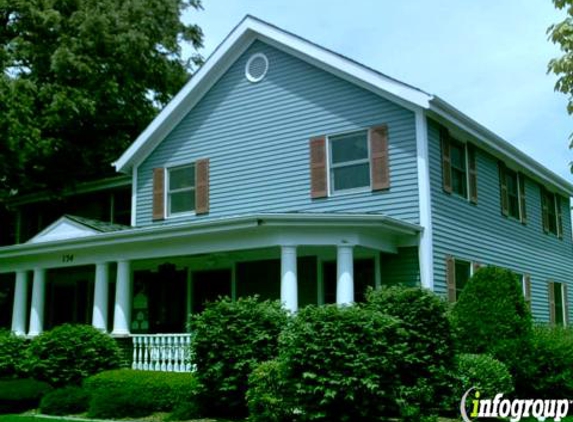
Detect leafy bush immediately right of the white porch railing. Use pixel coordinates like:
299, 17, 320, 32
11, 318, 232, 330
191, 297, 287, 417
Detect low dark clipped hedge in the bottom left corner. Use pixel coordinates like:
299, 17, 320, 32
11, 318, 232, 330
0, 379, 52, 413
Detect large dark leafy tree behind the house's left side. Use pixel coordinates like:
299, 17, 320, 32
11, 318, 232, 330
0, 0, 203, 199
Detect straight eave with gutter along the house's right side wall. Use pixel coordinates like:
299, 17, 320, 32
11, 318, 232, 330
430, 97, 573, 196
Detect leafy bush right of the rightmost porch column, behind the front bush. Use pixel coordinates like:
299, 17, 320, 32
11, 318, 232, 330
367, 286, 455, 420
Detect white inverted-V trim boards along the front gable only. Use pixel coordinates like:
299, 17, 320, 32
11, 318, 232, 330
113, 16, 431, 172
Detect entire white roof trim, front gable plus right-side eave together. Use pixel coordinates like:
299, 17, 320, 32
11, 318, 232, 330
113, 15, 573, 196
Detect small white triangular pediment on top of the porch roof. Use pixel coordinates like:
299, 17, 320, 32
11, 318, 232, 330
28, 215, 127, 243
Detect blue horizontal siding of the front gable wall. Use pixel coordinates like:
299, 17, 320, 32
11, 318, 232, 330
136, 41, 418, 226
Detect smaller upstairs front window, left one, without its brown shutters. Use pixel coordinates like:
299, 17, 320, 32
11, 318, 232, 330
167, 164, 195, 215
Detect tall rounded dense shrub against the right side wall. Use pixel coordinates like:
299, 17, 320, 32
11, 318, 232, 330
451, 267, 531, 361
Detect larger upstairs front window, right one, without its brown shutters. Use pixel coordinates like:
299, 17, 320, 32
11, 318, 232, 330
328, 130, 370, 192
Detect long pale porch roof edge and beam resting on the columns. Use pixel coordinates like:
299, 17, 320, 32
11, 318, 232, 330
0, 213, 422, 273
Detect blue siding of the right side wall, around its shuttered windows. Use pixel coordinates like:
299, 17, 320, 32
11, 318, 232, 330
428, 117, 573, 321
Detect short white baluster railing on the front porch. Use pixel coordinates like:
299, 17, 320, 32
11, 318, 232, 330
131, 334, 193, 372
